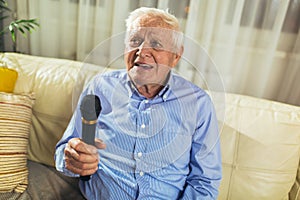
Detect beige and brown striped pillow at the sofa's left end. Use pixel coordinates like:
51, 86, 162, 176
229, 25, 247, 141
0, 92, 34, 193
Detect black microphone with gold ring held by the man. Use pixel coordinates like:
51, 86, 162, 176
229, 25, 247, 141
80, 94, 101, 181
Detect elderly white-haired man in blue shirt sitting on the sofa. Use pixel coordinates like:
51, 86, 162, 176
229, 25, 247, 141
55, 8, 221, 200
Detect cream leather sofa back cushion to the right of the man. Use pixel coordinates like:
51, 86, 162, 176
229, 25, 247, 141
219, 93, 300, 200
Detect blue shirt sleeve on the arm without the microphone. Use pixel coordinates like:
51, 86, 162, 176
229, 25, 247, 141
180, 94, 222, 200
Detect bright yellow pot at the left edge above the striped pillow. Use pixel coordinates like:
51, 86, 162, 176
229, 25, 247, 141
0, 67, 18, 93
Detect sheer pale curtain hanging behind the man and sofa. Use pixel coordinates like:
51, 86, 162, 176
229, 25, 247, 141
16, 0, 300, 106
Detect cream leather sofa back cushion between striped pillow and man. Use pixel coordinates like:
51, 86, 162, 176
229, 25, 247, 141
2, 53, 102, 166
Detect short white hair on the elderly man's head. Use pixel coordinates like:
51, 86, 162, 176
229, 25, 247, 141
125, 7, 183, 52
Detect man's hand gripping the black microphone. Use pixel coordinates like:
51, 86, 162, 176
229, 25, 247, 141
64, 138, 106, 176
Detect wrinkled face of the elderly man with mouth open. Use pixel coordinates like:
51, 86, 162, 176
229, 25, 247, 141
124, 24, 180, 87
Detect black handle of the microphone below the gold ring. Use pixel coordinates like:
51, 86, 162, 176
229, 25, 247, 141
80, 123, 96, 181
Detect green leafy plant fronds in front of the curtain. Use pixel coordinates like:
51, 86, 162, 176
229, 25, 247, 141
0, 0, 39, 42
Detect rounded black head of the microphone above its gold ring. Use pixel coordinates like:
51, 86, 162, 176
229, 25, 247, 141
80, 94, 101, 121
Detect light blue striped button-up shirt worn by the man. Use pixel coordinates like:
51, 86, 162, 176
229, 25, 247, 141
55, 70, 222, 200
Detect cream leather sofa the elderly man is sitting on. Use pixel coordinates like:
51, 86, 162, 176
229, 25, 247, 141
0, 53, 300, 200
